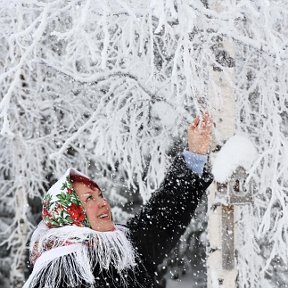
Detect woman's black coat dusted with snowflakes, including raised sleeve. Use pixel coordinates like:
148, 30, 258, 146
35, 155, 212, 288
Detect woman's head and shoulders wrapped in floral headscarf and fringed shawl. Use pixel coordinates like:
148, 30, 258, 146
24, 168, 136, 288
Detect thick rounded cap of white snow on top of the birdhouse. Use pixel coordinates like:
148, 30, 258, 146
212, 135, 258, 183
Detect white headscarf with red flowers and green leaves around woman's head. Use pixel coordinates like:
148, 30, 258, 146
42, 168, 90, 228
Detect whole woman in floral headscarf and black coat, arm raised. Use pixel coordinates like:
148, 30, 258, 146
23, 114, 212, 288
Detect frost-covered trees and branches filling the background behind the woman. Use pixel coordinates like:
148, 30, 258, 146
0, 0, 288, 288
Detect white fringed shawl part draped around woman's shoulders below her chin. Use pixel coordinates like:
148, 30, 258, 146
23, 221, 136, 288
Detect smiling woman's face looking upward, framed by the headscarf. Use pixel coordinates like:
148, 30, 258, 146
73, 182, 115, 232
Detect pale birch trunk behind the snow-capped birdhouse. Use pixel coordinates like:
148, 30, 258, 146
207, 0, 238, 288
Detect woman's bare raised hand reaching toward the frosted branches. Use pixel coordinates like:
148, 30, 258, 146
188, 112, 213, 154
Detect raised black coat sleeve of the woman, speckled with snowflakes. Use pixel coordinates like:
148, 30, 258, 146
127, 155, 213, 269
